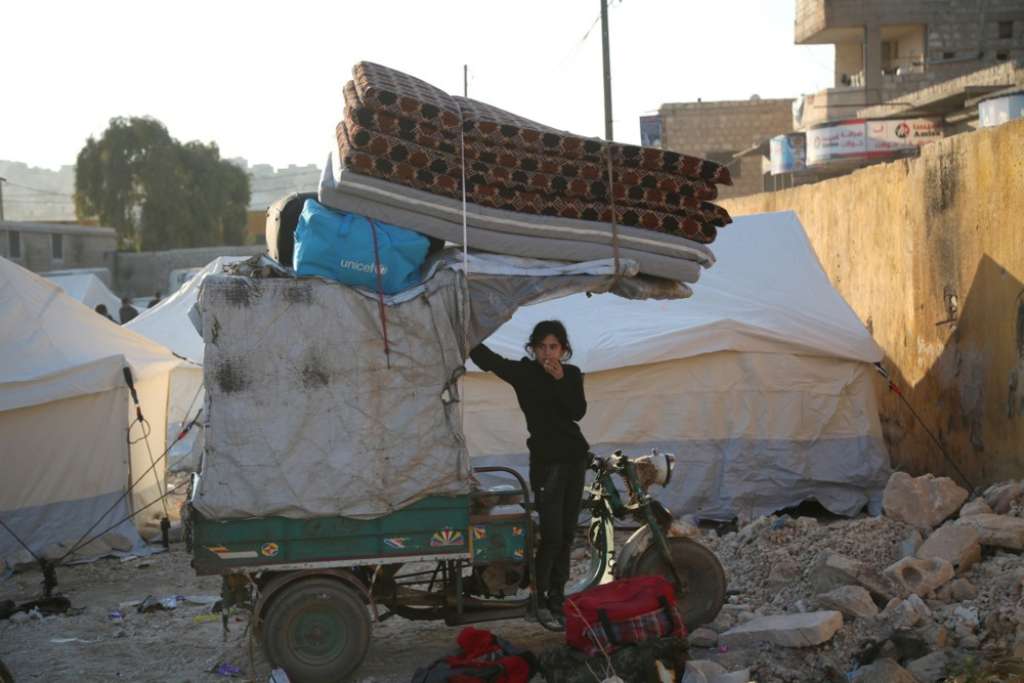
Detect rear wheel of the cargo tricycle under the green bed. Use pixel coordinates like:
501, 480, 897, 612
263, 578, 371, 683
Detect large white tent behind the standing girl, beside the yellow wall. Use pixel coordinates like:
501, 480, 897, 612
464, 212, 889, 519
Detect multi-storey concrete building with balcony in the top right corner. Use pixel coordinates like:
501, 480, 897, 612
795, 0, 1024, 130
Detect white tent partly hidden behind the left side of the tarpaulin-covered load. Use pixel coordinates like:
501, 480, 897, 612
125, 256, 245, 471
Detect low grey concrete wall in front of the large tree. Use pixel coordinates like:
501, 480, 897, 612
114, 245, 266, 297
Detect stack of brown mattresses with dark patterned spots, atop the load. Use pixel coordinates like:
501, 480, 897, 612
337, 62, 731, 243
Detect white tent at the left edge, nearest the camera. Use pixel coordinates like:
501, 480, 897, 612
0, 258, 181, 563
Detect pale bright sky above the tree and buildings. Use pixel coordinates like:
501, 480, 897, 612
0, 0, 833, 169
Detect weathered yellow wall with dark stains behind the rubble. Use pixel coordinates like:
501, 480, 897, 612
722, 121, 1024, 484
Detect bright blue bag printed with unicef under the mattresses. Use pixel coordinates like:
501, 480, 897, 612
293, 200, 430, 294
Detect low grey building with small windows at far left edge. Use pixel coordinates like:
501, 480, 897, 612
0, 220, 118, 272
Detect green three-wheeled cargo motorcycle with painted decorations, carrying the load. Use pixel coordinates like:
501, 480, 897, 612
185, 452, 726, 683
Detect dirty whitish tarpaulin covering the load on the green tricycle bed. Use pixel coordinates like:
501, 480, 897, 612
193, 252, 688, 518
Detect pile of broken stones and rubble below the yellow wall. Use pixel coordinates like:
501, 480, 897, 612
689, 472, 1024, 683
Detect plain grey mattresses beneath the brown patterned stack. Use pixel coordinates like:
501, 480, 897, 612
318, 156, 715, 283
